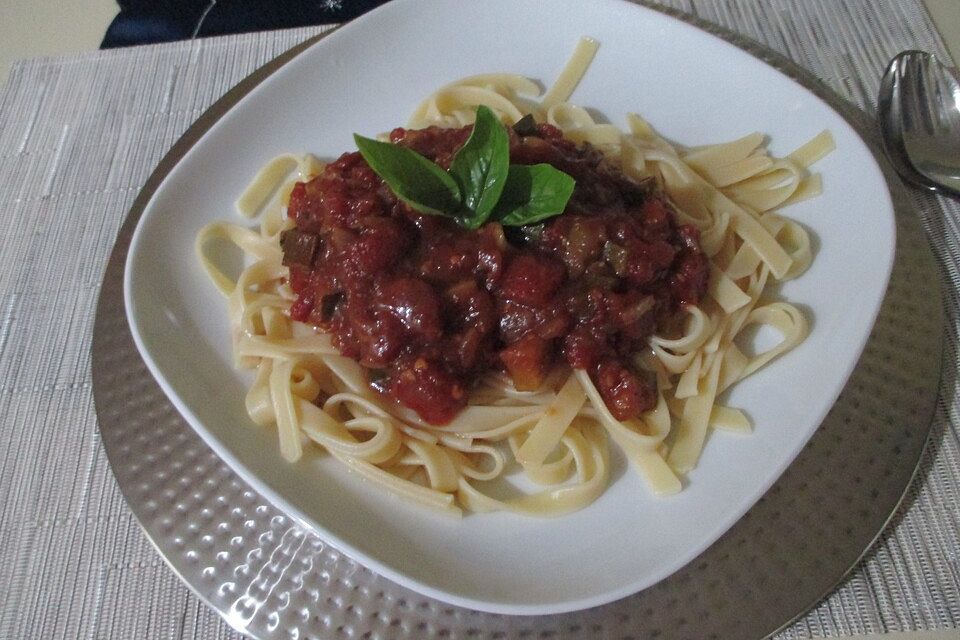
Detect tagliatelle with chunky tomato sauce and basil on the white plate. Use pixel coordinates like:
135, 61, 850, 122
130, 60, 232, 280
197, 39, 832, 515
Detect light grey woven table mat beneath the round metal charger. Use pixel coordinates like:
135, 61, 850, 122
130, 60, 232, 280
0, 0, 960, 639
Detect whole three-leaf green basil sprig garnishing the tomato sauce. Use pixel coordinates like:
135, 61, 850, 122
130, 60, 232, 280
353, 105, 576, 229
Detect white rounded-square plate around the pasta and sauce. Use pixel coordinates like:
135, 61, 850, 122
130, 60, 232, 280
124, 0, 894, 614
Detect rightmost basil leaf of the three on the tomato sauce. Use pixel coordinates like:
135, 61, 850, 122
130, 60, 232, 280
493, 164, 576, 227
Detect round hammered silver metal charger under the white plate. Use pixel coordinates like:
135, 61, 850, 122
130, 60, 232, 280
92, 7, 942, 639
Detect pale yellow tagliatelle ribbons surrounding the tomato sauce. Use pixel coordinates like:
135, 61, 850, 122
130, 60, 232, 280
196, 39, 833, 516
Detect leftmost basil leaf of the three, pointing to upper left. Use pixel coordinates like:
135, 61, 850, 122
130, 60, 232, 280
353, 134, 462, 216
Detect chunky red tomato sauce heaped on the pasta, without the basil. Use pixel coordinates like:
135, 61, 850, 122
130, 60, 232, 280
282, 125, 708, 425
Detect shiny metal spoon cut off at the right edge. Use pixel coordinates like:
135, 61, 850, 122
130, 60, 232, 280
877, 51, 960, 197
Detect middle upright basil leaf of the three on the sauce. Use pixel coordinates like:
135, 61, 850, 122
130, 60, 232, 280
450, 105, 510, 229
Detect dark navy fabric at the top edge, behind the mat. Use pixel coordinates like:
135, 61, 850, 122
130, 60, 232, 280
100, 0, 387, 49
